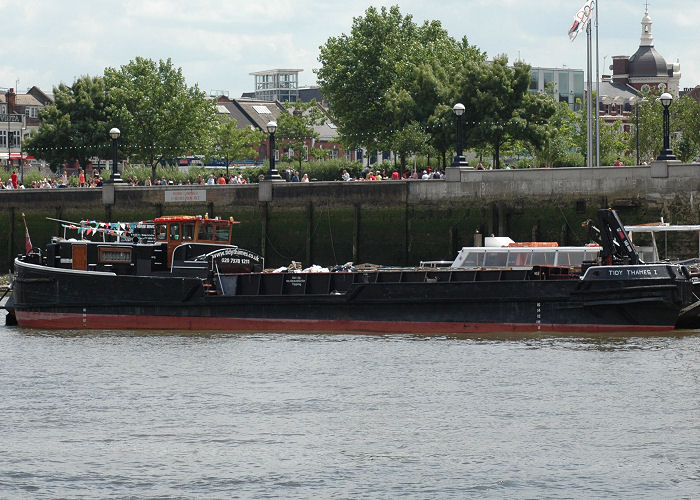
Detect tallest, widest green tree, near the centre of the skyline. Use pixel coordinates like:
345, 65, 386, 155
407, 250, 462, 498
316, 6, 485, 171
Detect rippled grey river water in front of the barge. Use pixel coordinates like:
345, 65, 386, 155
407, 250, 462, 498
0, 318, 700, 499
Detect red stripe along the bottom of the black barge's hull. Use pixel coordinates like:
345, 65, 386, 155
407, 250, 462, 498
16, 311, 674, 335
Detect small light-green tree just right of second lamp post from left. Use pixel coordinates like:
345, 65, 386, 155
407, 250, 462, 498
275, 99, 327, 170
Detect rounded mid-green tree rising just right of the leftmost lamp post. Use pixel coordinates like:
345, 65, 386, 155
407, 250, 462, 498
105, 57, 216, 180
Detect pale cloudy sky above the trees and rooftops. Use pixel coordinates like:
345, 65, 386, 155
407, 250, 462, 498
0, 0, 700, 97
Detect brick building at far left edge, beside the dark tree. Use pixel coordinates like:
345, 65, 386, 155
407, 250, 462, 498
0, 87, 53, 168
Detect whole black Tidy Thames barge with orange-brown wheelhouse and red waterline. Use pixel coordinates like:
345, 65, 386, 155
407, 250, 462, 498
5, 210, 699, 335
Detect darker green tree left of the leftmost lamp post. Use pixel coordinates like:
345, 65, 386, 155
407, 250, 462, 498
24, 76, 111, 172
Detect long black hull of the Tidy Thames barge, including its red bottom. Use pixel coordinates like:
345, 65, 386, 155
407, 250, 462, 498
8, 261, 693, 334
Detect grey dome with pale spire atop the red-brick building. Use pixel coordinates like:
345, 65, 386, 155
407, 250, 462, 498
610, 6, 681, 97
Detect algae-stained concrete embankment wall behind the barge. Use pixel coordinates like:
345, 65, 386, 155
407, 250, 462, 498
0, 165, 700, 272
